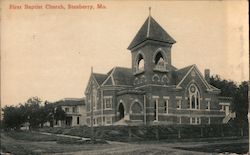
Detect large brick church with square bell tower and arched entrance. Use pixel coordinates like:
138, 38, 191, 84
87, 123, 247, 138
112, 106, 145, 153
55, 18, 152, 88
85, 11, 234, 126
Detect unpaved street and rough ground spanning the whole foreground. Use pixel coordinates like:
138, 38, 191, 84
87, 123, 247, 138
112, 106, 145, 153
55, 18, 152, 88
1, 131, 248, 155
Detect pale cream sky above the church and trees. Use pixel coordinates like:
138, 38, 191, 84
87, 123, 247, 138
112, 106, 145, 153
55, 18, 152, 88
1, 0, 249, 107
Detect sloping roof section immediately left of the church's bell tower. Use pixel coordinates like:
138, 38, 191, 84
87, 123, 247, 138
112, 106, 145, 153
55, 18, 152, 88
102, 67, 133, 86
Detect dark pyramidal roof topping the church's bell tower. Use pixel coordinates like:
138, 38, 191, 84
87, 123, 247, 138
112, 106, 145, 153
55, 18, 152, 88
128, 15, 176, 50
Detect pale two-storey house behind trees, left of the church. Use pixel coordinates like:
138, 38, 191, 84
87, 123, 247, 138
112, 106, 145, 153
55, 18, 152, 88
54, 98, 86, 127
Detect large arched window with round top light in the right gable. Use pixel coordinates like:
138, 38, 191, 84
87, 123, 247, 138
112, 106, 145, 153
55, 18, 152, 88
188, 84, 200, 109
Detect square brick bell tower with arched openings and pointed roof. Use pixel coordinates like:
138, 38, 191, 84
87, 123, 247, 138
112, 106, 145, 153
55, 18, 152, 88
128, 8, 176, 85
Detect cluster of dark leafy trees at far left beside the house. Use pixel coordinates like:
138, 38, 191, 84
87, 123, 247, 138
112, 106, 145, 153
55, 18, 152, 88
2, 97, 66, 129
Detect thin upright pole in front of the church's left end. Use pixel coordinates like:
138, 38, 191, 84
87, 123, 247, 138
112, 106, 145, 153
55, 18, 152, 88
90, 67, 95, 142
